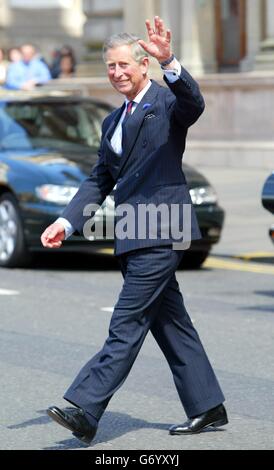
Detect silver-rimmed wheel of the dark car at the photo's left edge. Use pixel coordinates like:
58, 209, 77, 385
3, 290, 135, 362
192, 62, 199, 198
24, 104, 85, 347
0, 193, 30, 268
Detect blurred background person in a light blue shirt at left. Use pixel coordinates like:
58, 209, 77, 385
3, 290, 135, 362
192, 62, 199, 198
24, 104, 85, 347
5, 44, 51, 90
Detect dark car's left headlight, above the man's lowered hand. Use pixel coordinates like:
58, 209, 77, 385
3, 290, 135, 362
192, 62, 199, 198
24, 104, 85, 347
35, 184, 78, 206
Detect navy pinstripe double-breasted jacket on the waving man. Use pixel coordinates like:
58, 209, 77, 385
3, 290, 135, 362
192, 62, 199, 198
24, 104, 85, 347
62, 67, 204, 255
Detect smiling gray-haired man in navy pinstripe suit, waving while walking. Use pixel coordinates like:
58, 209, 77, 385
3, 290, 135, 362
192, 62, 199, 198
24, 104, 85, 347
41, 17, 228, 444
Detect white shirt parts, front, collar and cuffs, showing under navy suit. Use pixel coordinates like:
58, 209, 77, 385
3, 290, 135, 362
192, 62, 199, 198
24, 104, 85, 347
55, 59, 182, 239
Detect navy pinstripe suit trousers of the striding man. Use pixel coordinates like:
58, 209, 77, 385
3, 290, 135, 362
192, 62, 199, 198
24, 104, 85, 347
64, 245, 224, 420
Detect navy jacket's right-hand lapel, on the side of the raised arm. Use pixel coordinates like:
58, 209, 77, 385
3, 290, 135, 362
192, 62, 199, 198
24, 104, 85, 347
119, 80, 159, 177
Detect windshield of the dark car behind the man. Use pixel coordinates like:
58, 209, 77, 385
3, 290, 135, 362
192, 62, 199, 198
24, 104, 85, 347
0, 101, 110, 151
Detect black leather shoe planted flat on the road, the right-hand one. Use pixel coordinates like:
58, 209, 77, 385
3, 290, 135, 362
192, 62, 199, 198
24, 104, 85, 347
169, 405, 228, 435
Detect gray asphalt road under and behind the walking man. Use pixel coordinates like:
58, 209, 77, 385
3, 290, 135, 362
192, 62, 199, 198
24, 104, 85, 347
0, 167, 274, 450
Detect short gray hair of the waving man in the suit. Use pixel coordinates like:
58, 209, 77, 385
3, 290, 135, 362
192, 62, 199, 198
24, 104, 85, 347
103, 33, 148, 63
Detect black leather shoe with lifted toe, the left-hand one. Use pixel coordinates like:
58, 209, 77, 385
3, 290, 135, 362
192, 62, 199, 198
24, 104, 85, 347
47, 406, 97, 444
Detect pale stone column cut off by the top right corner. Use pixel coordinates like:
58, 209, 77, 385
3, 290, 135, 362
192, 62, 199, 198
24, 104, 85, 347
254, 0, 274, 70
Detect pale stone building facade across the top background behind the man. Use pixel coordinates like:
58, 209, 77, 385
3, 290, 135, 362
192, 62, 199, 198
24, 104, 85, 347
0, 0, 274, 75
